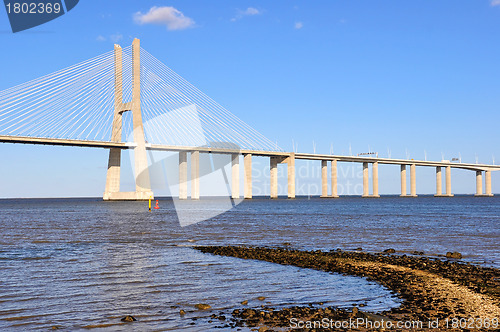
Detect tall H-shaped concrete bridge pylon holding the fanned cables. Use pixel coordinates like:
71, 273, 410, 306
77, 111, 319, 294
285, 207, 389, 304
103, 38, 154, 201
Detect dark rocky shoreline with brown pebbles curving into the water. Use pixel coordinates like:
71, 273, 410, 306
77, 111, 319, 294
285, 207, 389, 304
195, 246, 500, 331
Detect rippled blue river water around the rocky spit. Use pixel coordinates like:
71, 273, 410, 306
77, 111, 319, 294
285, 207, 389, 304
0, 196, 500, 331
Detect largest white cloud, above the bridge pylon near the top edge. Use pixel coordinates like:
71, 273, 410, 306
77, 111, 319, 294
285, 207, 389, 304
134, 6, 195, 30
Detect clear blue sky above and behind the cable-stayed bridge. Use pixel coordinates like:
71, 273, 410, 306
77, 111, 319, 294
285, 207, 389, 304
0, 0, 500, 197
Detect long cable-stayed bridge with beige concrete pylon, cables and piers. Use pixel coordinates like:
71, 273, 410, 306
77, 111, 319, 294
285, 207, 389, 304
0, 39, 500, 200
